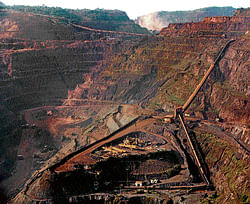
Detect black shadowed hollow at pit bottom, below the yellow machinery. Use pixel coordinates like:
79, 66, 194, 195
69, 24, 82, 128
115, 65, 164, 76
36, 151, 184, 198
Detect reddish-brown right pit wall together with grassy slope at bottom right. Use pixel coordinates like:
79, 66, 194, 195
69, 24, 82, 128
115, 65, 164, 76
57, 12, 249, 203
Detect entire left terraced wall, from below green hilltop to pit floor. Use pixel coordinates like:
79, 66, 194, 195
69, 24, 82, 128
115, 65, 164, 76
0, 8, 143, 111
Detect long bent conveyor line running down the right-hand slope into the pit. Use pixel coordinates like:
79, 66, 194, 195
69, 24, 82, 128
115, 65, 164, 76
164, 39, 235, 186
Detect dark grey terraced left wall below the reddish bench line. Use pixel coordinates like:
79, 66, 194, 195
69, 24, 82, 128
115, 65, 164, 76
0, 42, 111, 112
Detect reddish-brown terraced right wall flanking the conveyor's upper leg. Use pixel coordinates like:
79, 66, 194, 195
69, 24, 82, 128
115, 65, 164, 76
66, 13, 249, 124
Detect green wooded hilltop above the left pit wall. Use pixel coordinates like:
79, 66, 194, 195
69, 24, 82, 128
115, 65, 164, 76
8, 6, 149, 34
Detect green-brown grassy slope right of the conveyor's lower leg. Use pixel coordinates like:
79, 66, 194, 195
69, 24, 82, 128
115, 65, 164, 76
195, 128, 250, 203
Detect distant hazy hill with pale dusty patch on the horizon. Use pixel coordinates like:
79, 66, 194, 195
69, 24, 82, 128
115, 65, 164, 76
135, 7, 235, 31
